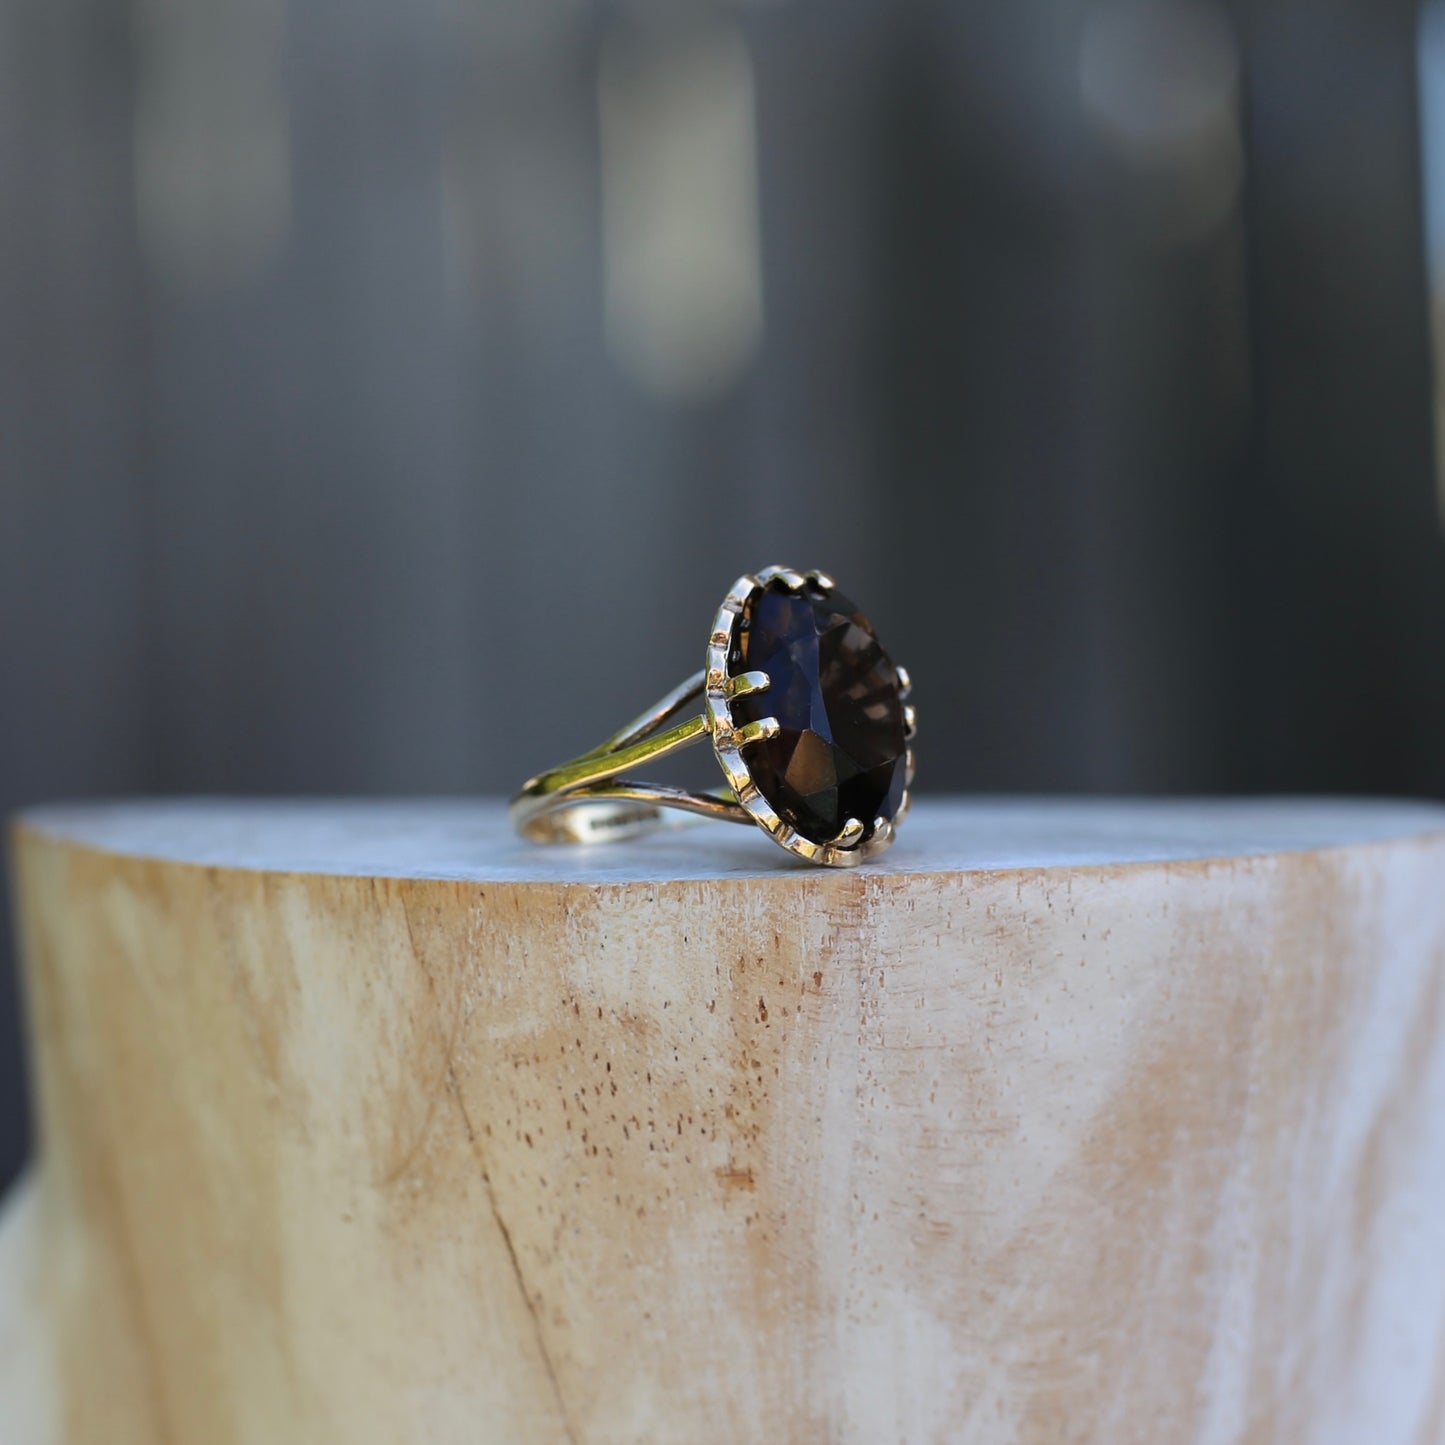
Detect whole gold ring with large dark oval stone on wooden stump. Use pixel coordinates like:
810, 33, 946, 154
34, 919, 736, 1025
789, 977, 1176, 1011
510, 566, 918, 868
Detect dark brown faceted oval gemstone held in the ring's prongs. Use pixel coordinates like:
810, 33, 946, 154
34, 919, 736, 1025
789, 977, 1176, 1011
728, 581, 907, 842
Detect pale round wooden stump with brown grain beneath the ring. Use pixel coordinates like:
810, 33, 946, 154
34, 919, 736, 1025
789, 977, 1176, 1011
0, 801, 1445, 1445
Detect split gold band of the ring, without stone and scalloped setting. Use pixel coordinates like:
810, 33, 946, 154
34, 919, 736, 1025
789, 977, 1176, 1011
509, 672, 753, 842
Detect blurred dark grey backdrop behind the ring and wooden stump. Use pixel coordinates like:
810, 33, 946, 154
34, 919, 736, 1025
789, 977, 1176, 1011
0, 0, 1445, 1181
